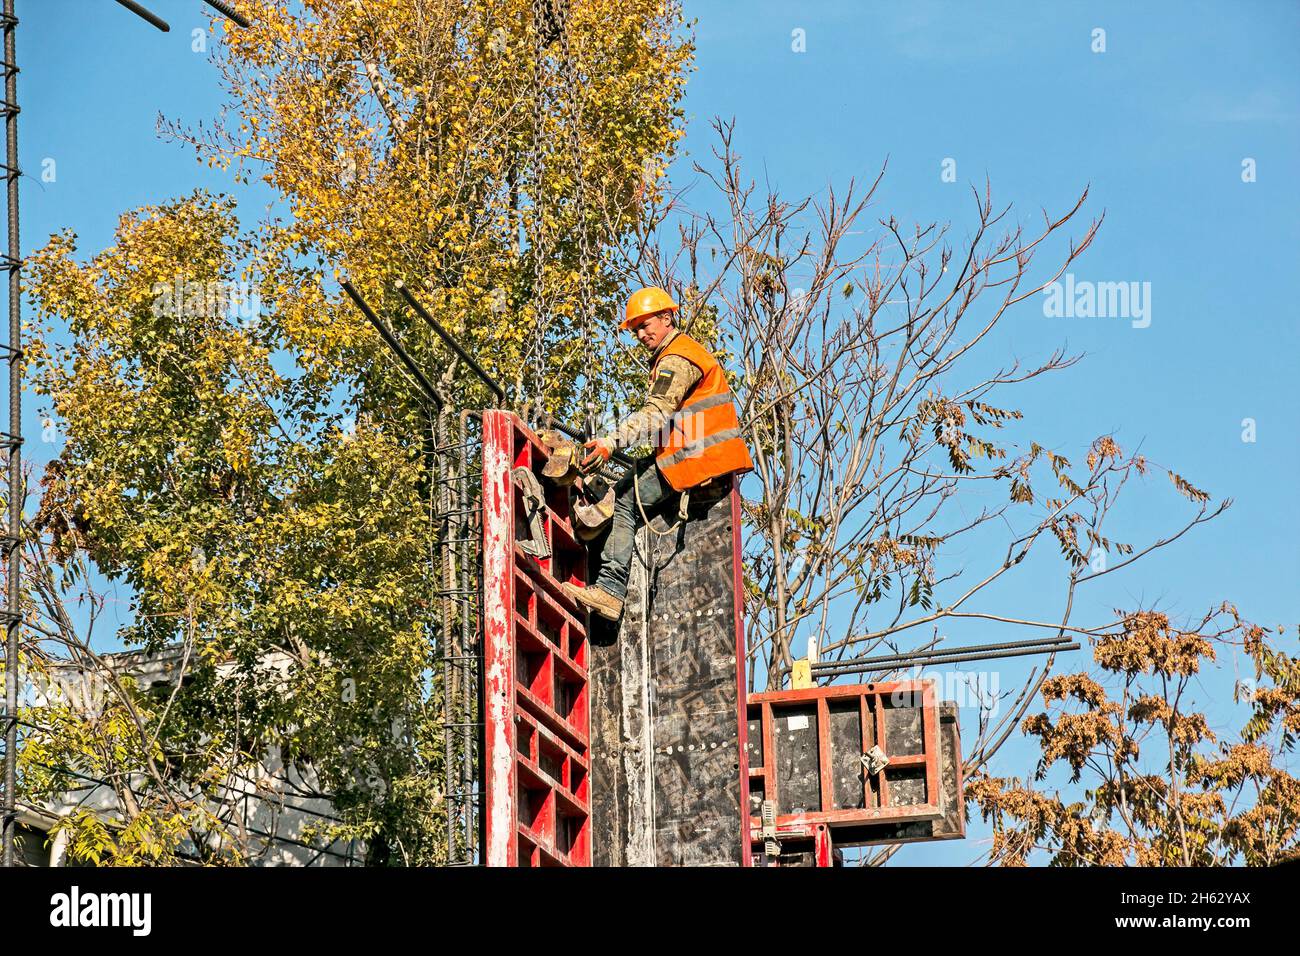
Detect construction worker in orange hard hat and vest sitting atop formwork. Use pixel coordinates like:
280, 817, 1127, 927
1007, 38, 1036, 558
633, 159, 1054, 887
564, 287, 754, 620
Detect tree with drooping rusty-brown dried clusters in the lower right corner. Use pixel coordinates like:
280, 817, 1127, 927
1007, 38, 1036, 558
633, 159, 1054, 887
966, 605, 1300, 866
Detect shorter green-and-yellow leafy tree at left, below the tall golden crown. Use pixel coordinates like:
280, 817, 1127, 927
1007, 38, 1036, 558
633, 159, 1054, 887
25, 194, 439, 862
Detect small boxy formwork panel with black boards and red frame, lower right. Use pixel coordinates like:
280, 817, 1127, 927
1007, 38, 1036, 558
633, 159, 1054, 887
749, 680, 965, 866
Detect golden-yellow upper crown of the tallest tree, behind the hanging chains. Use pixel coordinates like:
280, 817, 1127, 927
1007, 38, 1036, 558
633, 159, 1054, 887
165, 0, 692, 415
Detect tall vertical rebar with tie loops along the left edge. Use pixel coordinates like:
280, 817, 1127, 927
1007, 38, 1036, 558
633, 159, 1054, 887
3, 0, 22, 866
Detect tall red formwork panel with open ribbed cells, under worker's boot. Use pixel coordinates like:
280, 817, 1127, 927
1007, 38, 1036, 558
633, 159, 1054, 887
482, 411, 592, 866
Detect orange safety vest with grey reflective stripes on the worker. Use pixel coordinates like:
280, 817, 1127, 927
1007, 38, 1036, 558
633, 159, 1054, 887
650, 332, 754, 492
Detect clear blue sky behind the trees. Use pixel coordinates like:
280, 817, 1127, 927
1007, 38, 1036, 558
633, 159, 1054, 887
18, 0, 1300, 864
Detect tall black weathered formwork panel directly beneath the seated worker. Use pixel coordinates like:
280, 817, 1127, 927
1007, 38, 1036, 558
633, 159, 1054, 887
590, 478, 749, 866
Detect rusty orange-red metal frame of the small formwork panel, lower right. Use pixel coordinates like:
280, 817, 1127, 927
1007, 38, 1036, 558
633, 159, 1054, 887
749, 680, 961, 866
